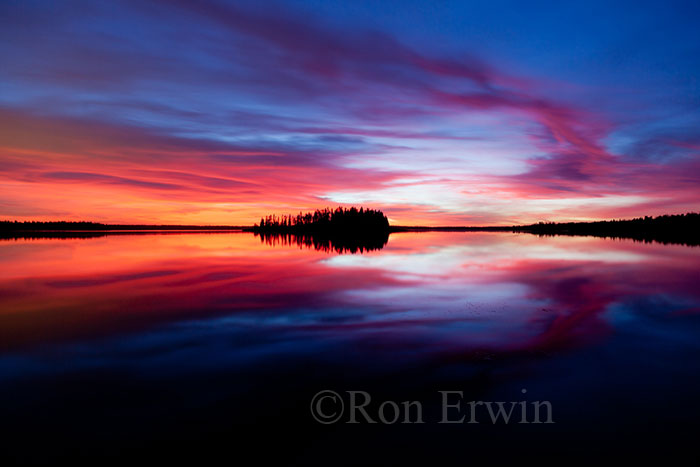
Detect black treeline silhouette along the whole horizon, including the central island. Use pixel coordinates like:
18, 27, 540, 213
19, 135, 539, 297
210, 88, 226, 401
0, 213, 700, 250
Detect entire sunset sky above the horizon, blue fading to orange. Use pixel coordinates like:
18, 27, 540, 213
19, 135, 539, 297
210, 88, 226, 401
0, 0, 700, 225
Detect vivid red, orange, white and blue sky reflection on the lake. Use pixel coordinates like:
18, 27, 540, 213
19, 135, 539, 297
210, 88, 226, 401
0, 233, 700, 352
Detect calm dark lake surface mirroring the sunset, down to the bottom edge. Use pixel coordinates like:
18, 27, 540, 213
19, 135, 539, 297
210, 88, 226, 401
0, 232, 700, 464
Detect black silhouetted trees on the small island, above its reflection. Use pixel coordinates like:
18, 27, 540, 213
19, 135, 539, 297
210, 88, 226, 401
253, 207, 389, 236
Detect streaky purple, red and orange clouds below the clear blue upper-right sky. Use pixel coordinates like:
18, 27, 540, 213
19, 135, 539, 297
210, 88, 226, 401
0, 1, 699, 224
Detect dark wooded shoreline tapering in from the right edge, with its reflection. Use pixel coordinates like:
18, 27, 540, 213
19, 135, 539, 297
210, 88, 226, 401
511, 213, 700, 245
